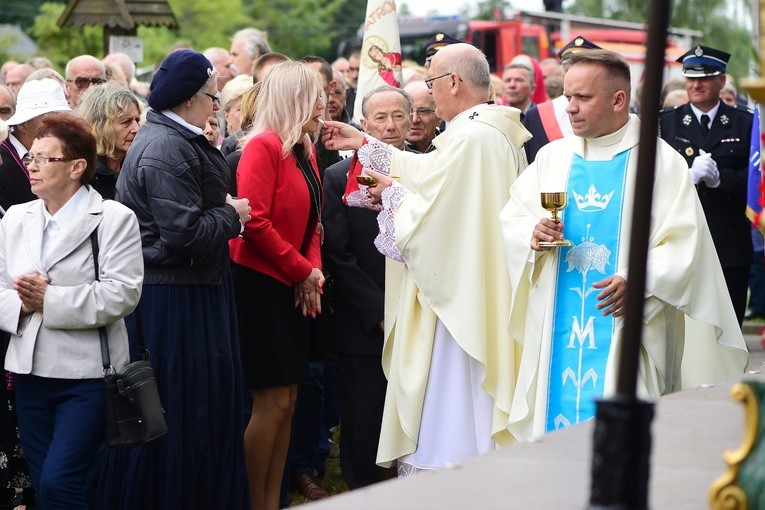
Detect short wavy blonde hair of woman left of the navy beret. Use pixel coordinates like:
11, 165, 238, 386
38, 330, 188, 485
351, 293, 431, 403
76, 82, 141, 158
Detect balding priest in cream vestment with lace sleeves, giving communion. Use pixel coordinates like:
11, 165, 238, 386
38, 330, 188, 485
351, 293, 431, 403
324, 44, 529, 475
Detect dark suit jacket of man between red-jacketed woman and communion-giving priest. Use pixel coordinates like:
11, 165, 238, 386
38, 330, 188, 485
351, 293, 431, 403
322, 158, 385, 356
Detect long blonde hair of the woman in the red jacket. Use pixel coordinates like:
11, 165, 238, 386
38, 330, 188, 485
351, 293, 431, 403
242, 62, 323, 157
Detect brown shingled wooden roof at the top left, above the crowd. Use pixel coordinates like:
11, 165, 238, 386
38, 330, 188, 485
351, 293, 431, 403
57, 0, 178, 30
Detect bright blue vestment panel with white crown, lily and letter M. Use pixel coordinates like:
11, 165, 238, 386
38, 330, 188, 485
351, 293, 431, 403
545, 150, 630, 432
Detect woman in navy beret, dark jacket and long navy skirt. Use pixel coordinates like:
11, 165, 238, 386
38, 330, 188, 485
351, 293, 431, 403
96, 50, 250, 510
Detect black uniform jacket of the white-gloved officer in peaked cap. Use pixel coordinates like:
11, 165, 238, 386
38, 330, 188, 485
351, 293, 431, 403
659, 102, 753, 268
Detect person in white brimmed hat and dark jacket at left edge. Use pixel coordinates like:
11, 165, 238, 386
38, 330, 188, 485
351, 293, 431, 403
0, 78, 71, 209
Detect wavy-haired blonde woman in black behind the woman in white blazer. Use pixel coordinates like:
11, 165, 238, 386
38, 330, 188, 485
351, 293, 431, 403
76, 83, 141, 199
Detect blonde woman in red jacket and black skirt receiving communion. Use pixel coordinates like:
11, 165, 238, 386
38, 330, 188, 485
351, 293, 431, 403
231, 62, 326, 510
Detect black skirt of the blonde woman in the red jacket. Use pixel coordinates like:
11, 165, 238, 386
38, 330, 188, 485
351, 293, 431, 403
232, 264, 308, 389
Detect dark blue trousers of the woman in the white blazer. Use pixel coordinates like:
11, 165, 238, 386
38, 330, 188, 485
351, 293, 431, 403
16, 375, 104, 510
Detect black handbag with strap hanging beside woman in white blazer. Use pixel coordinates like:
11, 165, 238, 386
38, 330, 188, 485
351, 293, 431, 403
90, 230, 167, 448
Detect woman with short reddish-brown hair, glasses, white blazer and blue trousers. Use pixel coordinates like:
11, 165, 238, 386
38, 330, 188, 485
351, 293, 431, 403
0, 113, 143, 510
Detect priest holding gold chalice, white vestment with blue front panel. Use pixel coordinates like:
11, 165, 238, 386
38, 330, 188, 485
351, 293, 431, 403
501, 50, 748, 440
